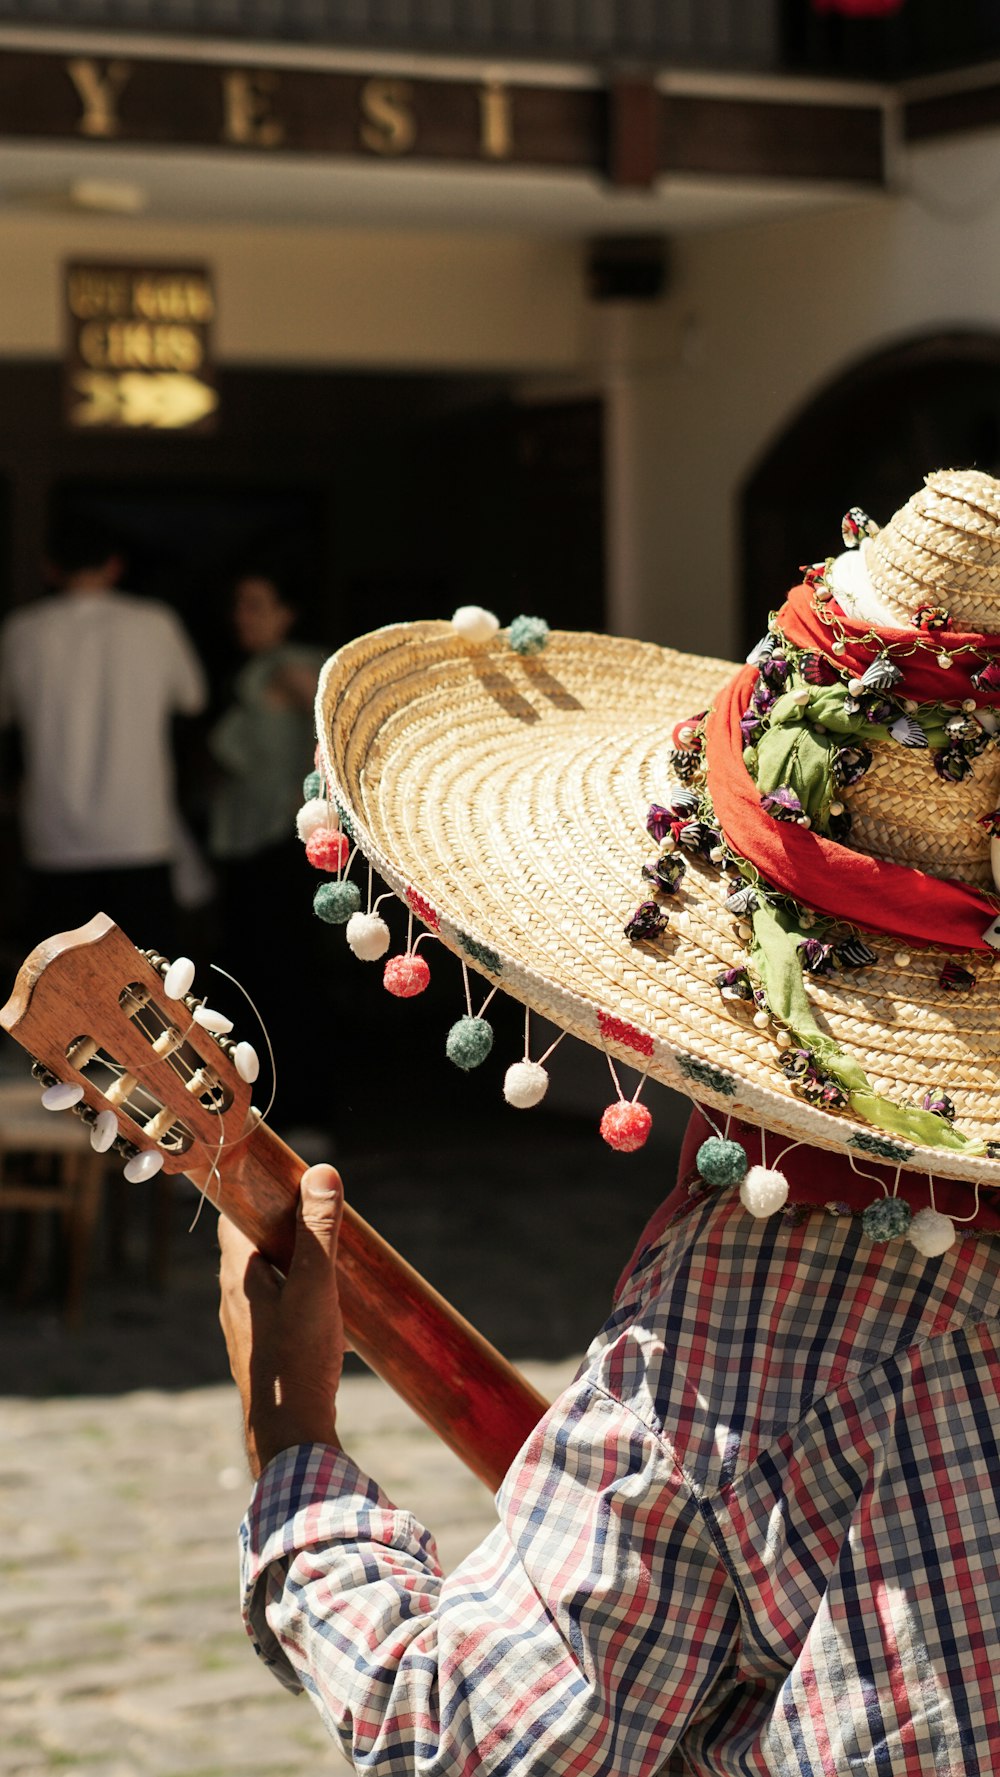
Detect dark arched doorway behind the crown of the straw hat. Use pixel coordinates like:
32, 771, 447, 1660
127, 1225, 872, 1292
741, 332, 1000, 647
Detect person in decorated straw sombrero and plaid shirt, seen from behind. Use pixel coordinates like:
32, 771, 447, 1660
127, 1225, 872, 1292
222, 471, 1000, 1777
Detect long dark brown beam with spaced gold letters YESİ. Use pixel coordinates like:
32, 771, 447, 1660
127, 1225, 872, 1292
0, 48, 886, 187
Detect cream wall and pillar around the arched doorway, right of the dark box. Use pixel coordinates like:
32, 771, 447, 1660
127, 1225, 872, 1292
606, 131, 1000, 654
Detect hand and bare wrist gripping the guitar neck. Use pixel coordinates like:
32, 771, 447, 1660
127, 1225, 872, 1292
218, 1166, 345, 1480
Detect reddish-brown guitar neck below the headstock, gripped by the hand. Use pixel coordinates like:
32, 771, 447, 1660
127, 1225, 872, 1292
188, 1123, 549, 1489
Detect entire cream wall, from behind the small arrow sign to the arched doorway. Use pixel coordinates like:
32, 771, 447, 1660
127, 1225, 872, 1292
0, 131, 1000, 654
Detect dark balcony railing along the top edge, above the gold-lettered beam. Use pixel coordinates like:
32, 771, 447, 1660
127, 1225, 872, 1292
0, 0, 1000, 80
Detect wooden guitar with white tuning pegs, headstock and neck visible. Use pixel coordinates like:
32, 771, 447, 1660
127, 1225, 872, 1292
0, 913, 549, 1487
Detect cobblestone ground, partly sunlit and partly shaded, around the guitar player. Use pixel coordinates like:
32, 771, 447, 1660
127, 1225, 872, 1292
0, 1112, 685, 1777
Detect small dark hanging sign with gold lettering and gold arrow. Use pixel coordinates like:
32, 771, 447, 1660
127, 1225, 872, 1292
66, 265, 218, 432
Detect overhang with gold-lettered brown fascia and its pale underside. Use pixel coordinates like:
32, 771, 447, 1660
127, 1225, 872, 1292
0, 28, 895, 235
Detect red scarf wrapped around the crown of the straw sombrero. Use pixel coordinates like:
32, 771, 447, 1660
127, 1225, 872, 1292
705, 586, 1000, 954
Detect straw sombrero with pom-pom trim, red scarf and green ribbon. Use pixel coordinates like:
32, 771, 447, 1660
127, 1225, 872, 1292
300, 471, 1000, 1236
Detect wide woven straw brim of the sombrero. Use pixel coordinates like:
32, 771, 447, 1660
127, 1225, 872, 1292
316, 622, 1000, 1185
